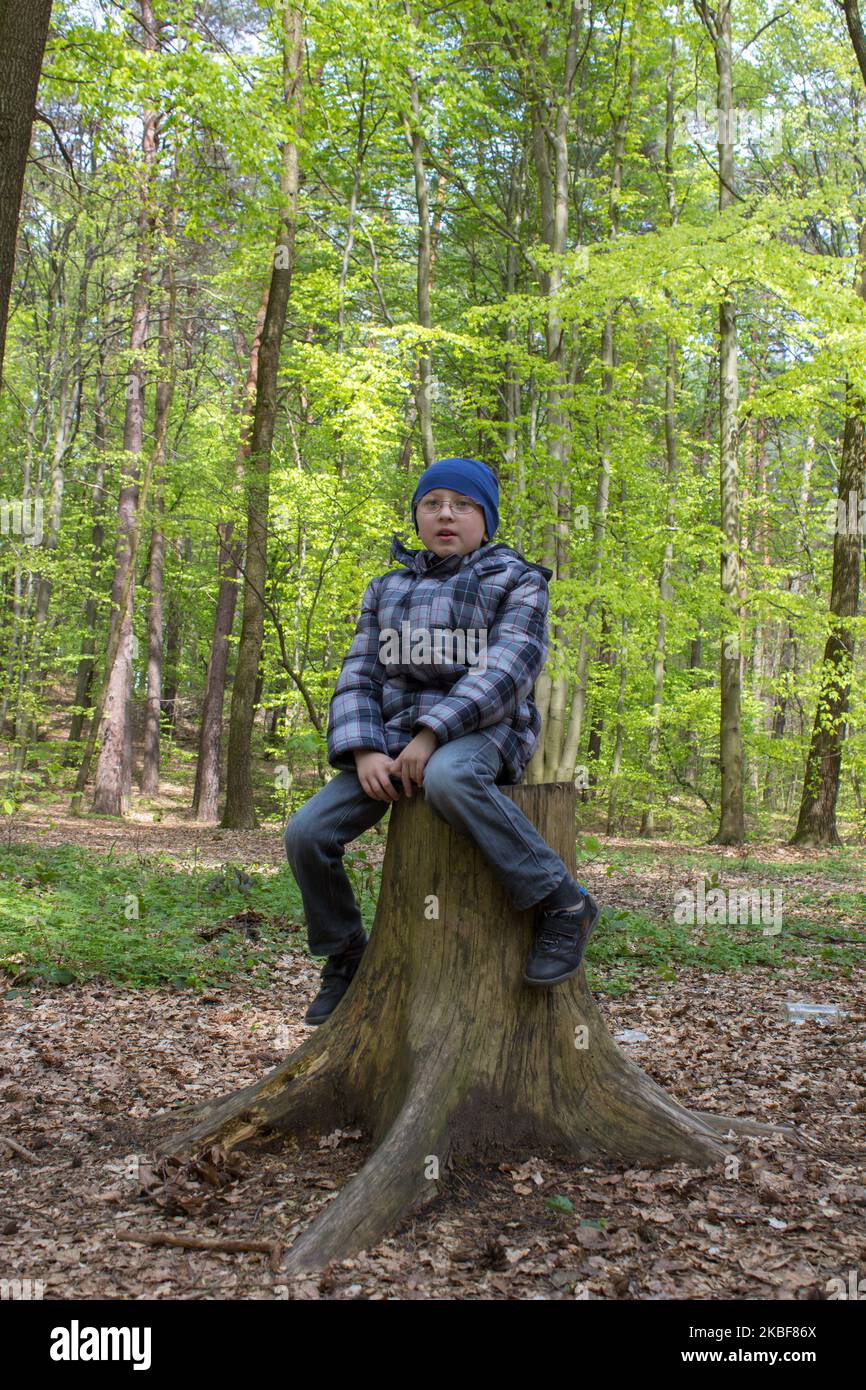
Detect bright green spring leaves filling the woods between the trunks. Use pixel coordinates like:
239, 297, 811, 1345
0, 0, 866, 840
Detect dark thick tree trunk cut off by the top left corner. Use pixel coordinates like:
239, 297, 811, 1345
0, 0, 51, 385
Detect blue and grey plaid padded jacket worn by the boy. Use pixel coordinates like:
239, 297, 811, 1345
328, 535, 553, 783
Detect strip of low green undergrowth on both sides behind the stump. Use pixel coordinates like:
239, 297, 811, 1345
0, 837, 866, 995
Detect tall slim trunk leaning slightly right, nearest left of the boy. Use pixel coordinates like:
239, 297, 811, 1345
222, 6, 303, 830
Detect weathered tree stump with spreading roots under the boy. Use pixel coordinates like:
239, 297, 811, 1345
161, 783, 774, 1273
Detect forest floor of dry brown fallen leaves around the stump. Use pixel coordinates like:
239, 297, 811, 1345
0, 789, 866, 1300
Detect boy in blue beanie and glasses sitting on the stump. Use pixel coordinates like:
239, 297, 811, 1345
285, 459, 599, 1024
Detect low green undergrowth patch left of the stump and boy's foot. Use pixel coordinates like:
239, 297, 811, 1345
0, 844, 306, 988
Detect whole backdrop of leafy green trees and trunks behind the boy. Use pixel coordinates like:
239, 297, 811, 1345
0, 0, 866, 844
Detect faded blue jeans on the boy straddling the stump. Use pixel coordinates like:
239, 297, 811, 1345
284, 733, 583, 956
